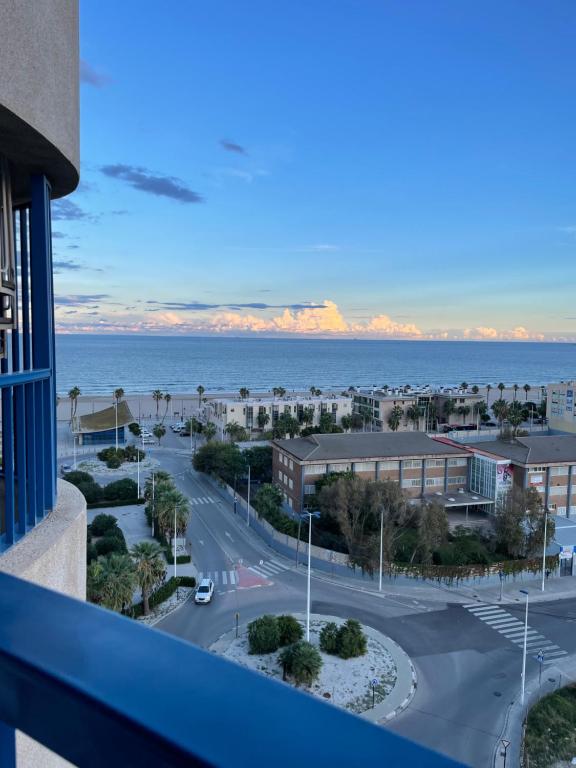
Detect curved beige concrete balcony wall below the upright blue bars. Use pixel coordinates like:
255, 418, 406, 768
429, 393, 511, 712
0, 480, 86, 768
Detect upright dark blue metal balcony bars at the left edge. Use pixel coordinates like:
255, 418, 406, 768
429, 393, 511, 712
0, 176, 56, 552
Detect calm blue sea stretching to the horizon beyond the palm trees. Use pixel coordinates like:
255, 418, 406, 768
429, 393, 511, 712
56, 334, 576, 395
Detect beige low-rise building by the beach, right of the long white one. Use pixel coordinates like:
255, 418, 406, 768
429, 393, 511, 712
353, 387, 484, 432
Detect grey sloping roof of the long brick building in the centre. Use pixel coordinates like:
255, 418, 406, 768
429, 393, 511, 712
273, 432, 471, 461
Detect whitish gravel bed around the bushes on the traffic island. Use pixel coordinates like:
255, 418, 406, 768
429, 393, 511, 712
223, 619, 397, 713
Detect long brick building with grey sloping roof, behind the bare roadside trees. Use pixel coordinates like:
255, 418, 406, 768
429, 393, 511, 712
272, 432, 482, 512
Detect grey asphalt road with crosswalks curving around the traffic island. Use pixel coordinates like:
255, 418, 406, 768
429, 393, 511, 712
59, 432, 576, 768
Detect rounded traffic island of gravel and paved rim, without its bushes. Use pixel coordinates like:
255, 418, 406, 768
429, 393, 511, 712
210, 614, 416, 723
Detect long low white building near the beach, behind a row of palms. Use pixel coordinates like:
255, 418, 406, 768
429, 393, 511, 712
204, 394, 352, 434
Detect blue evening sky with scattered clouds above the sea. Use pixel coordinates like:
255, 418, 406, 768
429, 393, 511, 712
53, 0, 576, 341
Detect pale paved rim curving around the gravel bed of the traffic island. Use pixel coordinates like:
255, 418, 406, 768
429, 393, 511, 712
208, 613, 418, 724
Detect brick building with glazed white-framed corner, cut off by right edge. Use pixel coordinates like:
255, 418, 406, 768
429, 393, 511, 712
467, 435, 576, 517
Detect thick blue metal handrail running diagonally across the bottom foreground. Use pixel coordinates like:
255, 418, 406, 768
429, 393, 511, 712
0, 574, 459, 768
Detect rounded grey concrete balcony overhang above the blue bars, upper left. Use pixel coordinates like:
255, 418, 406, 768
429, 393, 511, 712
0, 0, 80, 200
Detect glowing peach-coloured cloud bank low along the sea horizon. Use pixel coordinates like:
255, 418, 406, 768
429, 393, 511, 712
56, 295, 552, 341
